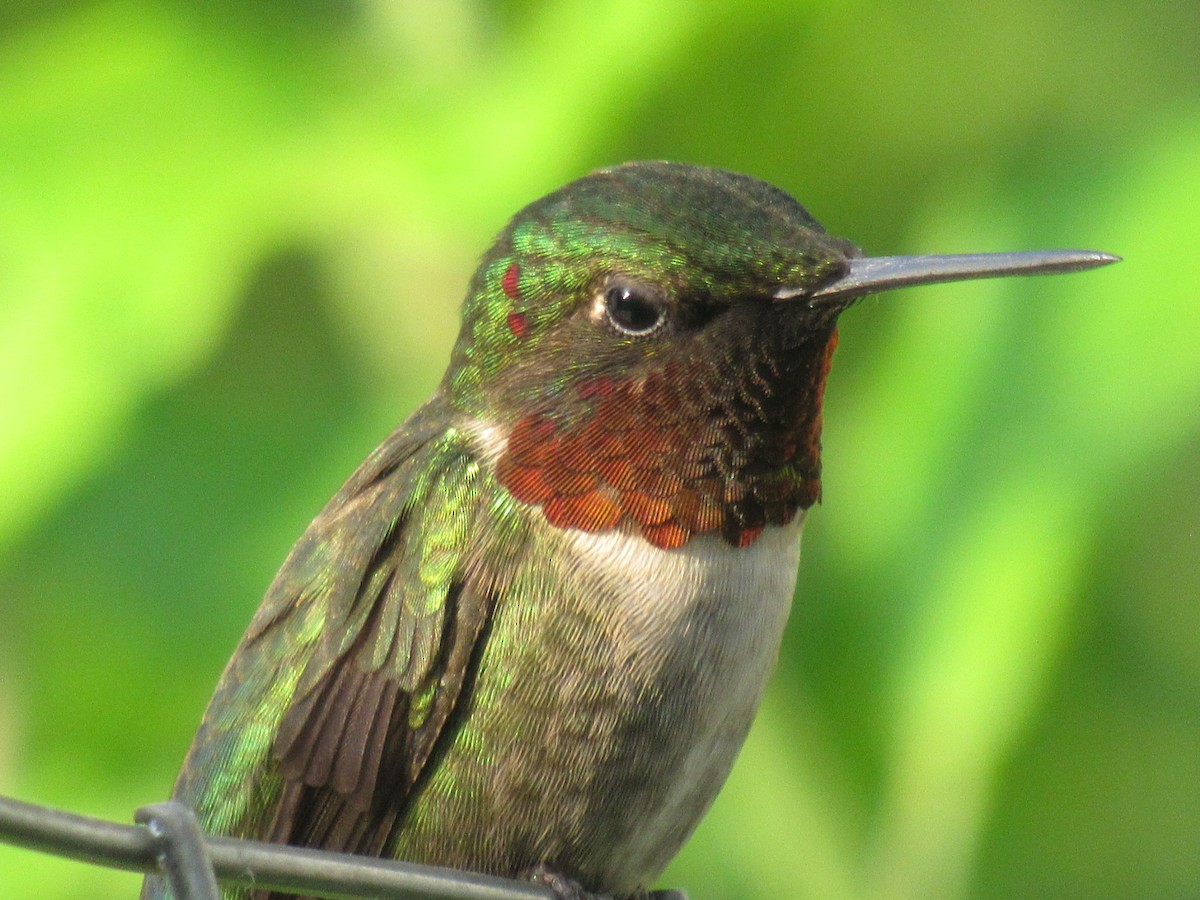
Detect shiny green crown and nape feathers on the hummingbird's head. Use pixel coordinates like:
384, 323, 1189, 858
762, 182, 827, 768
446, 163, 857, 413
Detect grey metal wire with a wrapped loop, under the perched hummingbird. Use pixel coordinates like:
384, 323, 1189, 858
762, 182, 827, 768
0, 797, 554, 900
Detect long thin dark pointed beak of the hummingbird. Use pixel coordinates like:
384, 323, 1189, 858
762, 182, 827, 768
775, 250, 1121, 305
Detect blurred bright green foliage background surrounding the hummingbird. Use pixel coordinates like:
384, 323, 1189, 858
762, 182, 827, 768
0, 0, 1200, 900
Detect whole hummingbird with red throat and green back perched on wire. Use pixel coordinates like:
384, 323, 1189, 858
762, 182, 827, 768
143, 162, 1117, 898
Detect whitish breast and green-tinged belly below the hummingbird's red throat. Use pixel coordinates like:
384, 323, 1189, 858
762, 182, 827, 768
395, 515, 803, 894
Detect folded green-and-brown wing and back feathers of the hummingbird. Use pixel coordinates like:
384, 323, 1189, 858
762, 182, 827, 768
163, 414, 491, 888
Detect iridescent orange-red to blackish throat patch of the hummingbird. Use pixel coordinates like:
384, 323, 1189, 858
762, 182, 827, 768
497, 335, 836, 550
